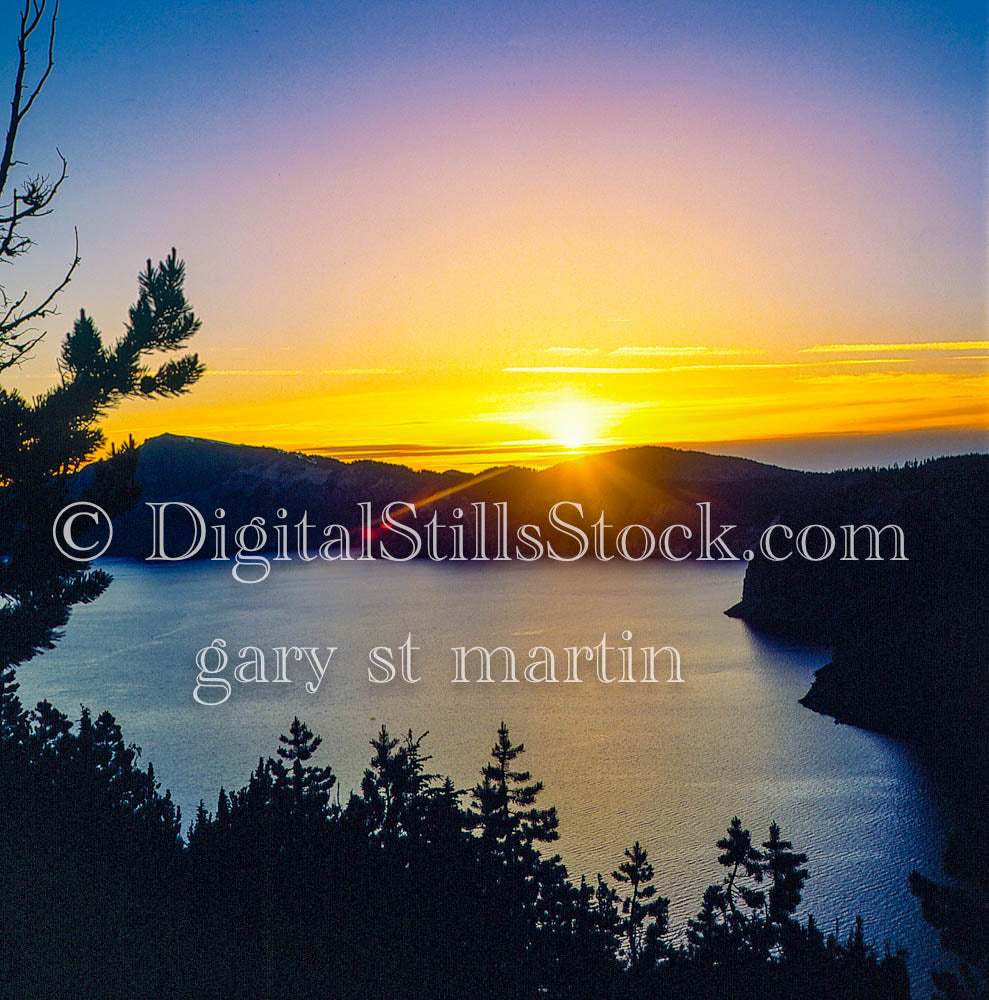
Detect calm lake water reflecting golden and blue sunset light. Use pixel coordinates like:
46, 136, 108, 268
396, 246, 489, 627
20, 562, 948, 996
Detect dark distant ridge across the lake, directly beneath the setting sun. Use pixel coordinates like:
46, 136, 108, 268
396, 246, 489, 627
73, 434, 822, 558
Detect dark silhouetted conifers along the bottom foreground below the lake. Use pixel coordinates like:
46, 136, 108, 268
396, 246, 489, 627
0, 670, 909, 1000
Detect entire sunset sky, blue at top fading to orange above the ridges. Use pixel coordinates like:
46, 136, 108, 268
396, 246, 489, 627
0, 0, 989, 469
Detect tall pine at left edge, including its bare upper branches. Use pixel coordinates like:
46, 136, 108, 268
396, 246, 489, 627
0, 0, 203, 688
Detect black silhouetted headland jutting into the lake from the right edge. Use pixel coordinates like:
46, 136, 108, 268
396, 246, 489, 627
727, 455, 989, 784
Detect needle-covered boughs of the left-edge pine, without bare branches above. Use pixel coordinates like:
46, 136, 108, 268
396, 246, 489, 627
0, 250, 203, 669
